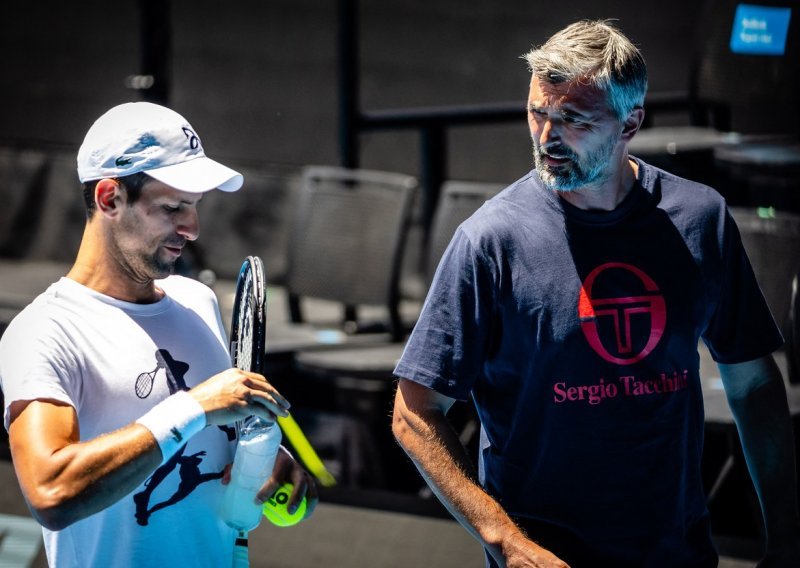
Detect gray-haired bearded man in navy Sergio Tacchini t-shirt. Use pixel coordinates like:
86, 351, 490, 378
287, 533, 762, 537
393, 21, 800, 568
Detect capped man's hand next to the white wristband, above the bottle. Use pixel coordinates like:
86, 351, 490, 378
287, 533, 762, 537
189, 368, 290, 425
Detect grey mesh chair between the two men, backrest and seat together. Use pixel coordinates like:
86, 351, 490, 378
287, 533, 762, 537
266, 166, 417, 366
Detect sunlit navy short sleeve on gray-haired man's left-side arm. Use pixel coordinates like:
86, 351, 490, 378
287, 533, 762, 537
394, 229, 494, 400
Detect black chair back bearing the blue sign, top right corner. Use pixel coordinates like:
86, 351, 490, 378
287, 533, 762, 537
643, 0, 800, 136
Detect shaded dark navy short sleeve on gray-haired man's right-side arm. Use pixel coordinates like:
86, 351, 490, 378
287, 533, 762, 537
703, 213, 783, 364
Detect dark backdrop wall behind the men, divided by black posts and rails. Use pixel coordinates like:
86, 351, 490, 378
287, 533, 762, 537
0, 0, 697, 181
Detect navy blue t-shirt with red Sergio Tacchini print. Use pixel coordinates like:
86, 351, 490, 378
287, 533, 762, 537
395, 161, 782, 568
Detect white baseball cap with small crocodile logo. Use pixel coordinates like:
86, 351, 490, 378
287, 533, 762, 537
78, 102, 244, 193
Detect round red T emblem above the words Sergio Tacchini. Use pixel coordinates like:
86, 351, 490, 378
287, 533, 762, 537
578, 262, 667, 365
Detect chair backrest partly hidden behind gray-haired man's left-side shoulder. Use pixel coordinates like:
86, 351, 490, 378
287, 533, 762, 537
425, 180, 506, 284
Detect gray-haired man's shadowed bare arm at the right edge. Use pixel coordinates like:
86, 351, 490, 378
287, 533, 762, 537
719, 356, 800, 566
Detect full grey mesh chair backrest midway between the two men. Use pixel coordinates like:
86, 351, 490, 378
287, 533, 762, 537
285, 166, 417, 332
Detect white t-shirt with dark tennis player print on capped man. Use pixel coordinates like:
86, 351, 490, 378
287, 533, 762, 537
0, 276, 236, 567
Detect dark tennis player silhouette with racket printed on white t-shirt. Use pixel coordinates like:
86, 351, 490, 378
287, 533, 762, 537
133, 349, 225, 526
